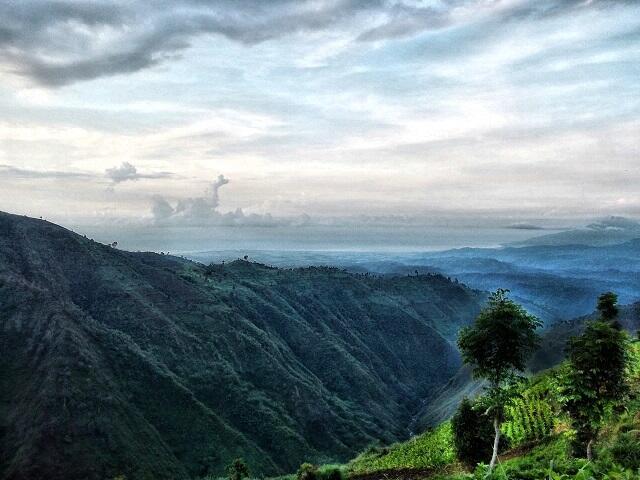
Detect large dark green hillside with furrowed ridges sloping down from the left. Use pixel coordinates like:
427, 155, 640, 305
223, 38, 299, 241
0, 213, 483, 480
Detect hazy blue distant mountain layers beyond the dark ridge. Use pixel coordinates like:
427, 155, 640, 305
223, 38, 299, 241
189, 236, 640, 325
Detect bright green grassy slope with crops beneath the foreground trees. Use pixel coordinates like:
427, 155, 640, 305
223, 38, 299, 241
276, 342, 640, 480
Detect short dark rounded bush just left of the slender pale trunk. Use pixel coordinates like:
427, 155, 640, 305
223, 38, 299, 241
451, 398, 493, 466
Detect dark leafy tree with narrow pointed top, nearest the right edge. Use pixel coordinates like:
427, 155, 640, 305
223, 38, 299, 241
560, 292, 628, 460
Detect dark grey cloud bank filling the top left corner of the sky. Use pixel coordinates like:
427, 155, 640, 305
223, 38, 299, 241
0, 0, 383, 87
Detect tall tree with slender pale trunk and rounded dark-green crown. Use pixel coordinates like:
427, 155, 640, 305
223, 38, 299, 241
458, 289, 542, 471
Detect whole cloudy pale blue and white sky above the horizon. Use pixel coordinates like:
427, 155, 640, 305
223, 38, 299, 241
0, 0, 640, 249
